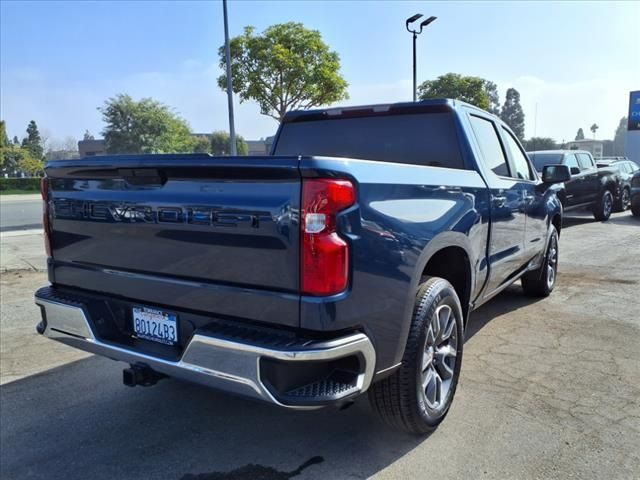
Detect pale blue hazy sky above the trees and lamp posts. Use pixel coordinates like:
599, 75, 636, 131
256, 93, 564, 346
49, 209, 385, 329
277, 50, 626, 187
0, 0, 640, 145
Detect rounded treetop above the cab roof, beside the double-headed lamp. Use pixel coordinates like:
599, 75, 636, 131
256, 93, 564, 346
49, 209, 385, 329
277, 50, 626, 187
418, 73, 499, 113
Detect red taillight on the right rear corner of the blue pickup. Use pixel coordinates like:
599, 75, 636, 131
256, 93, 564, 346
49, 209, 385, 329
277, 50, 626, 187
300, 179, 356, 295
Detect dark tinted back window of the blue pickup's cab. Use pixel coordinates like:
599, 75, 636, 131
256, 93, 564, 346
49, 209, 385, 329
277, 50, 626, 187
274, 111, 465, 169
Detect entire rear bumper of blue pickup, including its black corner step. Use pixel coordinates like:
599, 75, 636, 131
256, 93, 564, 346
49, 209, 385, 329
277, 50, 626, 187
35, 288, 376, 408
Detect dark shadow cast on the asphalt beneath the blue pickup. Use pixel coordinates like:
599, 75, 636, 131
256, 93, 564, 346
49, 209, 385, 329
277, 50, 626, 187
0, 286, 536, 480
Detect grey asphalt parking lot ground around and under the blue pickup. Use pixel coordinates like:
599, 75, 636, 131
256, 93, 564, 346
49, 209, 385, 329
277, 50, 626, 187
0, 212, 640, 480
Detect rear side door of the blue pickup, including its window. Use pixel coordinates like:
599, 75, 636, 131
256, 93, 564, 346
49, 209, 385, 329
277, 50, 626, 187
469, 113, 526, 295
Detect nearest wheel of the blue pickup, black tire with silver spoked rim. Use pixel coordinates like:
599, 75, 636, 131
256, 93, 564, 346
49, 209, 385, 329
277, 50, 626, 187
369, 277, 464, 435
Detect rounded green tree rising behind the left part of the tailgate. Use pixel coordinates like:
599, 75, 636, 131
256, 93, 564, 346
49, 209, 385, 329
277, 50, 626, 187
98, 94, 194, 153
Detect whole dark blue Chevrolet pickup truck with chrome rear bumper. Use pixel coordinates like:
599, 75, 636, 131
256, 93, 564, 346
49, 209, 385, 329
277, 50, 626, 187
35, 100, 570, 433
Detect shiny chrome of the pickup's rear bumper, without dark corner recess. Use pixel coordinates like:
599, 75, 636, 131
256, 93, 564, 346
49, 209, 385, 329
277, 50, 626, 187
35, 292, 376, 408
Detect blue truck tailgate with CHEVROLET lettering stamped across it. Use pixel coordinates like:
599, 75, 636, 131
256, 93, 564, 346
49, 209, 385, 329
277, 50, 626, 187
46, 155, 301, 326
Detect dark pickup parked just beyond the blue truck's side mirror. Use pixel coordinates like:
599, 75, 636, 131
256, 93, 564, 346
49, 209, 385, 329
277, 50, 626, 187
528, 150, 623, 221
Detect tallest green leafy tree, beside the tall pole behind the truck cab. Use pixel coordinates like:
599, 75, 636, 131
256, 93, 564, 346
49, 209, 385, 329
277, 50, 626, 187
218, 22, 348, 122
